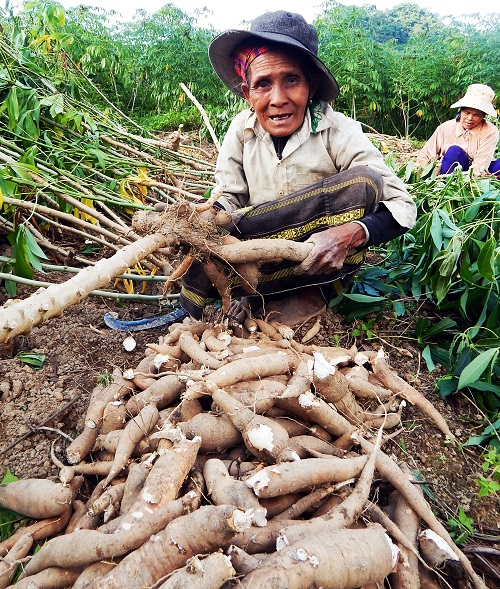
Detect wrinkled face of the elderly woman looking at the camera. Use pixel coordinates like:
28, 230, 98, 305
241, 50, 316, 137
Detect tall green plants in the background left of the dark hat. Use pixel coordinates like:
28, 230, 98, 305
66, 4, 218, 120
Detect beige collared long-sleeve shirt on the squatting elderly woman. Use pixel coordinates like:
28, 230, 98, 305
215, 102, 416, 228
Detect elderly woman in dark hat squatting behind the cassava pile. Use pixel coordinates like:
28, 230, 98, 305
181, 11, 416, 326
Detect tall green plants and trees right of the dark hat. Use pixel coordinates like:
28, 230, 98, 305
315, 1, 500, 139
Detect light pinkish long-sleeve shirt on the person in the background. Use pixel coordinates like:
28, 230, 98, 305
417, 119, 498, 174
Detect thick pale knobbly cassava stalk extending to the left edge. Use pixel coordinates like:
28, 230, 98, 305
0, 234, 169, 342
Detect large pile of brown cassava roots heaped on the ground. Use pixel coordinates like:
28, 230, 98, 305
0, 320, 486, 589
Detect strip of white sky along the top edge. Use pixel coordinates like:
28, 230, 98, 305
59, 0, 500, 31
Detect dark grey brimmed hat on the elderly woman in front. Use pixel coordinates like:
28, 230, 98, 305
208, 10, 340, 101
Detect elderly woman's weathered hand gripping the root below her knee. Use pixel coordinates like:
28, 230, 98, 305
295, 223, 366, 274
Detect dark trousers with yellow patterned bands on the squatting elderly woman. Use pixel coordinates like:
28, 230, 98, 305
180, 166, 382, 319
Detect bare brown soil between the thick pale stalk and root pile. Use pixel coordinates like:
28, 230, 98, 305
0, 296, 181, 480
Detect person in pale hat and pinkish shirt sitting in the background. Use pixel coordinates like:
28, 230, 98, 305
417, 84, 500, 176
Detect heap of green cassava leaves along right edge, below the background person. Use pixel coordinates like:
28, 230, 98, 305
350, 168, 500, 447
